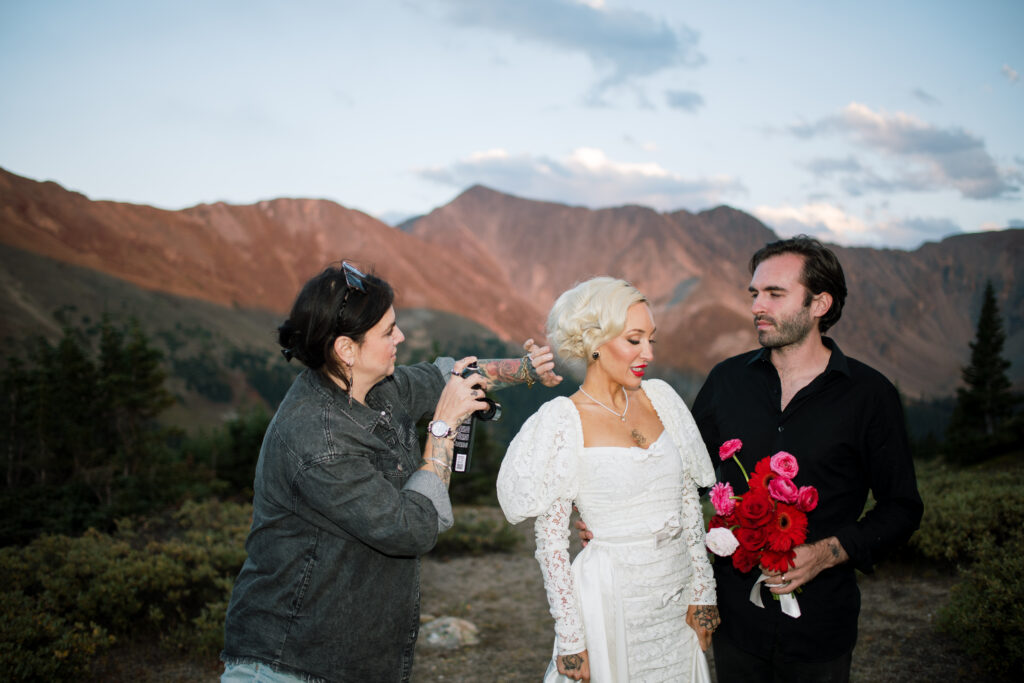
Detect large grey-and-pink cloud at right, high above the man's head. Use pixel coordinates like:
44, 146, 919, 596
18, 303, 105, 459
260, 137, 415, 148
788, 102, 1019, 200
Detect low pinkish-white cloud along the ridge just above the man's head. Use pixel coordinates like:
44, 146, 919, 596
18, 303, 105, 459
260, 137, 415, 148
754, 202, 962, 249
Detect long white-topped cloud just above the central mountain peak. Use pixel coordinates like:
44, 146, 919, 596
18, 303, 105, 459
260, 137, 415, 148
416, 147, 746, 211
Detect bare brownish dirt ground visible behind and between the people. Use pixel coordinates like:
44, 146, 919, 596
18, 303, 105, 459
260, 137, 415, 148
413, 511, 985, 683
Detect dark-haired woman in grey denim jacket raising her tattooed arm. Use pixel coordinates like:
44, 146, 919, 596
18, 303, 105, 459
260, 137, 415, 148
221, 262, 561, 681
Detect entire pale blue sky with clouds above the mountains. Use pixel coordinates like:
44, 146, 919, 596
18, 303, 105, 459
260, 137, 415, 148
0, 0, 1024, 249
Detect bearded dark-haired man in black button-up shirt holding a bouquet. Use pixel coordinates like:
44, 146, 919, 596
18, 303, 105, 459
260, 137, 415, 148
693, 236, 923, 683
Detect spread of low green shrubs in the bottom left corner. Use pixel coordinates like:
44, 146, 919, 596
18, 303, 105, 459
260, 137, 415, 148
0, 501, 252, 680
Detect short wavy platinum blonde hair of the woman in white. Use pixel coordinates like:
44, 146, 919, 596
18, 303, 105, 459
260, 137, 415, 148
547, 276, 647, 368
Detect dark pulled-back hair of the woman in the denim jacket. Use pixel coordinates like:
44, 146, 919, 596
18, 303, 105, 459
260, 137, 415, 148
278, 264, 394, 391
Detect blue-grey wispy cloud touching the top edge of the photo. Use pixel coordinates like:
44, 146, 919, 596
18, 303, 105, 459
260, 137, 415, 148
442, 0, 705, 101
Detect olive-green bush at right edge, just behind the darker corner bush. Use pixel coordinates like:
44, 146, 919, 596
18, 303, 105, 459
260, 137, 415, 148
910, 463, 1024, 566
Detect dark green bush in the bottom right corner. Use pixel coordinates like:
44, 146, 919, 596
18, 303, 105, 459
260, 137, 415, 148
938, 526, 1024, 680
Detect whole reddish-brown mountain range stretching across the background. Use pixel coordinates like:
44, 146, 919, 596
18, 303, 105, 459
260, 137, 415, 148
0, 169, 1024, 405
